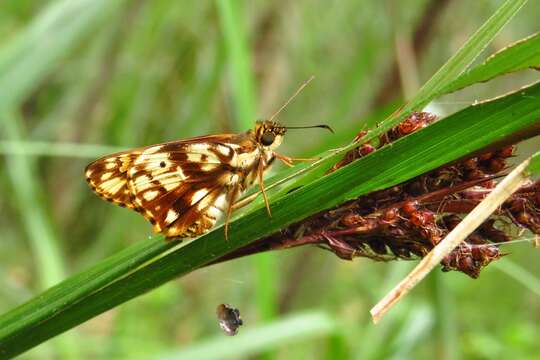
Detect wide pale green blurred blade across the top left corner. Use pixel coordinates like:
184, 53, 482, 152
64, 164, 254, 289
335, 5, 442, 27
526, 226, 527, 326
0, 0, 123, 113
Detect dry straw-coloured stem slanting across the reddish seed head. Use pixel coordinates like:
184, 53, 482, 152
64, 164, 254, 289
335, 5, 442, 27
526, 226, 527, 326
370, 157, 531, 324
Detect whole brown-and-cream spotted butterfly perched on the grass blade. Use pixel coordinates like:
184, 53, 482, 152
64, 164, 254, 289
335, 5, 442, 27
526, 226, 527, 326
85, 79, 332, 239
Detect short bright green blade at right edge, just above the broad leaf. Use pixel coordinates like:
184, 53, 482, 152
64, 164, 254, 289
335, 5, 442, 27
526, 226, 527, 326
440, 33, 540, 95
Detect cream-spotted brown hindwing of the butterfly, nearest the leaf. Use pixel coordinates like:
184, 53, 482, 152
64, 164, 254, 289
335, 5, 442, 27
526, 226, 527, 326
129, 142, 234, 237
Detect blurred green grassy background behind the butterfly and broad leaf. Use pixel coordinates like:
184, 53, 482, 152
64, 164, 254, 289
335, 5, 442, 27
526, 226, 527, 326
0, 0, 540, 359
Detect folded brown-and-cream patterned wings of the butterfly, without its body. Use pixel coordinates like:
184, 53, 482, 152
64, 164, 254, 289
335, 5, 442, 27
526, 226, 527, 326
86, 135, 253, 237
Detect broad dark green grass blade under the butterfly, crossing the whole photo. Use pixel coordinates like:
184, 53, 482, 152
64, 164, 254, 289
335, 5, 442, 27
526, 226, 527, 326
0, 79, 540, 355
